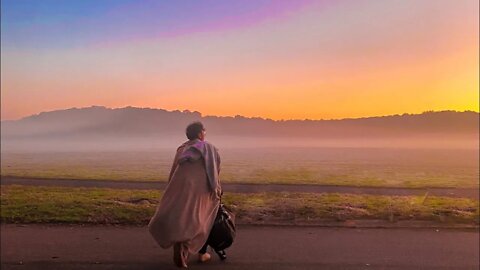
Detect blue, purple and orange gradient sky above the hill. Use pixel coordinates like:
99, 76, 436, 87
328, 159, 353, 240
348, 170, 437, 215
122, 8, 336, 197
1, 0, 479, 120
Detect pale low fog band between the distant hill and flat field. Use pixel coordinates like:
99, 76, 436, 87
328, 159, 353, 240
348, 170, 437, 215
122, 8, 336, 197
1, 133, 478, 153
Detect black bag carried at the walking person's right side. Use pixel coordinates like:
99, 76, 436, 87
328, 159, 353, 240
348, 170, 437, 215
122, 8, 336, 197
207, 203, 236, 260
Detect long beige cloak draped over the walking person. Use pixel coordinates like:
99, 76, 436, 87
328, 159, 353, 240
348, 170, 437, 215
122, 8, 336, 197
148, 139, 221, 253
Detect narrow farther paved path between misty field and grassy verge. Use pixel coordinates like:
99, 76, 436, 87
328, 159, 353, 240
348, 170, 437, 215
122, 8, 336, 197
1, 177, 479, 200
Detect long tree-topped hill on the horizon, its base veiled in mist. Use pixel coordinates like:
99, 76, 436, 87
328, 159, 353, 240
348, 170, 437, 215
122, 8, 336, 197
1, 106, 479, 152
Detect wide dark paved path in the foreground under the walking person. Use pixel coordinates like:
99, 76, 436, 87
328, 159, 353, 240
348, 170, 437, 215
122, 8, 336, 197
1, 225, 480, 270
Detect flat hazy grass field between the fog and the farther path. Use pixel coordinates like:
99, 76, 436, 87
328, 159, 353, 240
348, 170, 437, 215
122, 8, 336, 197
1, 148, 479, 188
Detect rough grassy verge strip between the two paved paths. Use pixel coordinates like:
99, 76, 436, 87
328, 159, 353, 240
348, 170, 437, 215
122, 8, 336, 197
1, 186, 479, 225
